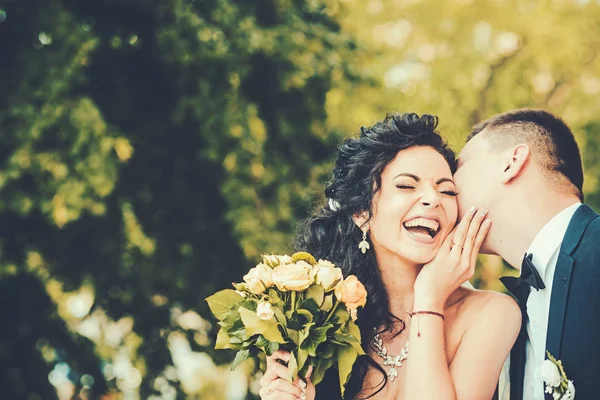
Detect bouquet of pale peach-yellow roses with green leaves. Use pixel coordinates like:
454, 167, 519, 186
206, 252, 367, 394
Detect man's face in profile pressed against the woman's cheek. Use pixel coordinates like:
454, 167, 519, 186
454, 130, 502, 218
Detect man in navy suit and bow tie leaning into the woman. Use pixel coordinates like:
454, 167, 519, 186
454, 110, 600, 400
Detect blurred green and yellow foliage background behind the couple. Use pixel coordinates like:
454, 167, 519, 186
0, 0, 600, 399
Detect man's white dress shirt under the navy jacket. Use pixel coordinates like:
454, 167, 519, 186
523, 203, 581, 400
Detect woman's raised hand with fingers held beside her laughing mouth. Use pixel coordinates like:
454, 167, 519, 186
414, 207, 492, 312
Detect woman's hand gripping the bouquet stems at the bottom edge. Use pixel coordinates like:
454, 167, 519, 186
258, 350, 316, 400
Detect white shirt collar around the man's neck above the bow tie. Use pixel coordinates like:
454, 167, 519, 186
527, 202, 581, 280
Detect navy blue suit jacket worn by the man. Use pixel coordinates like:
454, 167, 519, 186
510, 204, 600, 400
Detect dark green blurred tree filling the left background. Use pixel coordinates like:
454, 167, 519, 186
0, 0, 354, 399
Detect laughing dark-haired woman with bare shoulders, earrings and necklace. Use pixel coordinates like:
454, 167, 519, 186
259, 114, 521, 400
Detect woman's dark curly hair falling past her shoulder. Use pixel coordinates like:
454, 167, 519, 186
296, 113, 456, 399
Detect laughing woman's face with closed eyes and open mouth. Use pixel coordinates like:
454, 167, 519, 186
368, 146, 458, 264
